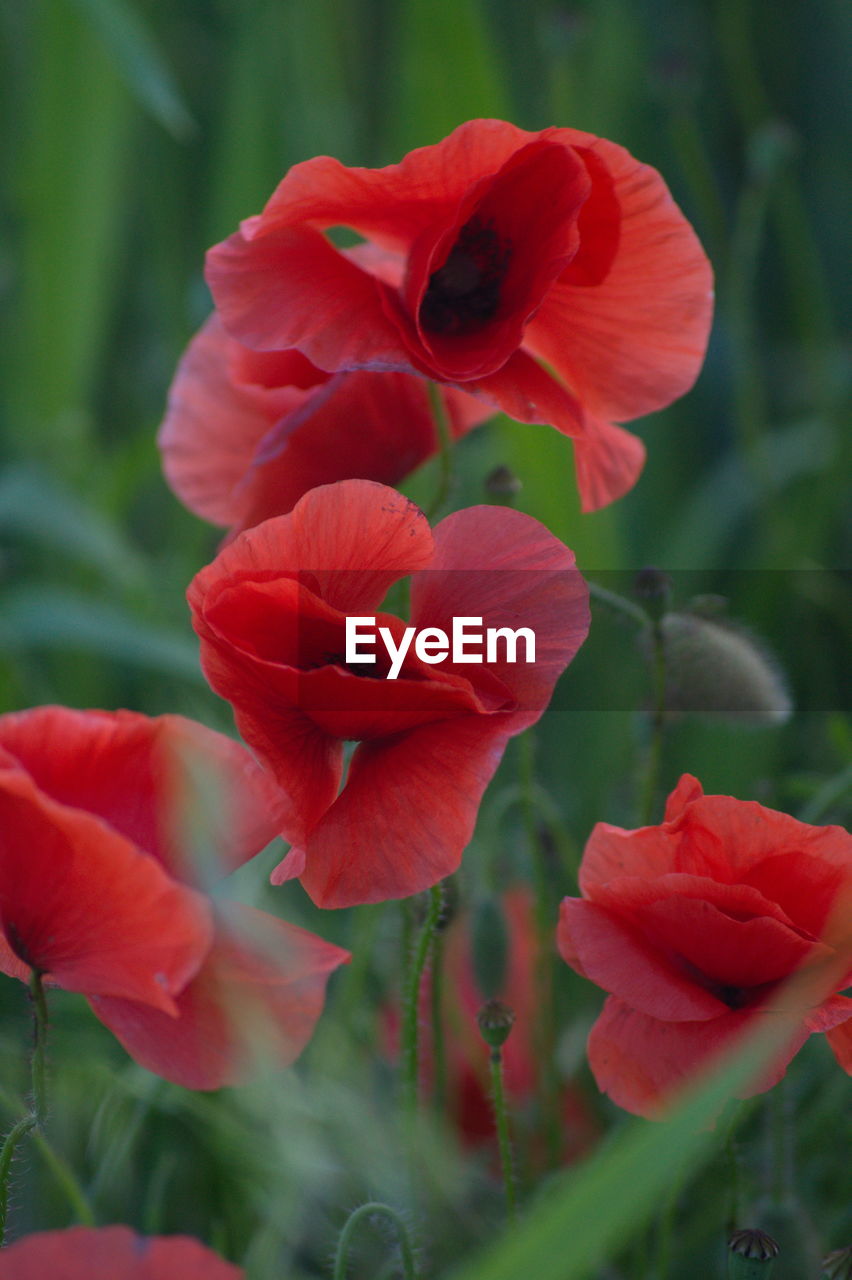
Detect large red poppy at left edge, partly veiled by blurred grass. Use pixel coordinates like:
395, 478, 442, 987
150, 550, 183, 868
0, 707, 345, 1088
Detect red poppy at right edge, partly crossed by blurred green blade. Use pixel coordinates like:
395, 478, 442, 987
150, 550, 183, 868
558, 774, 852, 1115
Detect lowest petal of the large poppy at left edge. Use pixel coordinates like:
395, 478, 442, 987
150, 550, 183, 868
92, 905, 349, 1089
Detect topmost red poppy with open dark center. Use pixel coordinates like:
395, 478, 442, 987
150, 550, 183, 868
207, 120, 713, 509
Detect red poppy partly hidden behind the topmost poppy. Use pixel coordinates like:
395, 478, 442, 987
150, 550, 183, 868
159, 314, 491, 532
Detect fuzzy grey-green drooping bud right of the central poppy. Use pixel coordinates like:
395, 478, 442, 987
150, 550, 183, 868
660, 613, 792, 724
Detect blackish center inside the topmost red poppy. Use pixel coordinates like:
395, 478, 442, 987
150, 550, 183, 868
420, 218, 512, 334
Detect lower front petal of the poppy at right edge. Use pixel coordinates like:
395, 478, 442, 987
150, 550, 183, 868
587, 996, 810, 1119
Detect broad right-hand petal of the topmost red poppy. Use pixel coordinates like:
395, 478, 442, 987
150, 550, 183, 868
526, 131, 713, 421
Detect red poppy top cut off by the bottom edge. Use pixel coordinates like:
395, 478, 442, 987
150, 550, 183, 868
0, 1226, 243, 1280
